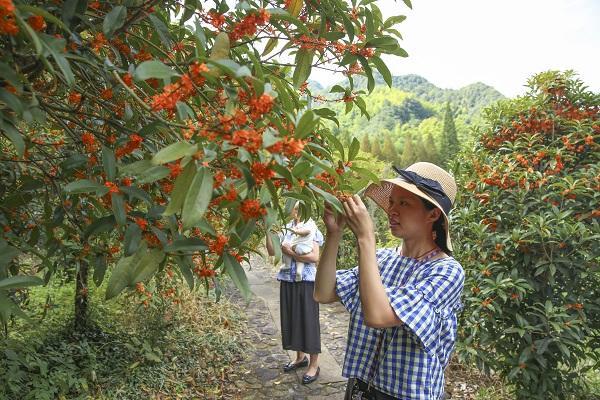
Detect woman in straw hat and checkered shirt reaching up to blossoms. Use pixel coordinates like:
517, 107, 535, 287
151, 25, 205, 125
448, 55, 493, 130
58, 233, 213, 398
314, 162, 464, 400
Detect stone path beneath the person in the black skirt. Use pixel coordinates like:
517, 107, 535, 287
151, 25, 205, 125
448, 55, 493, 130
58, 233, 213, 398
227, 256, 348, 400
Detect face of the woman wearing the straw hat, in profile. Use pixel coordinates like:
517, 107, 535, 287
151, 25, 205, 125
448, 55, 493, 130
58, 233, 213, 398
388, 186, 440, 239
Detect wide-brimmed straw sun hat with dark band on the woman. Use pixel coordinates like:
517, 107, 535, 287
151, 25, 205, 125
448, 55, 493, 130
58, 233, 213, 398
365, 162, 456, 251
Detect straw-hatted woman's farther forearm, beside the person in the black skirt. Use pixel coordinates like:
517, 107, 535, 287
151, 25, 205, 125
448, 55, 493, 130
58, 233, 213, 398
313, 231, 342, 304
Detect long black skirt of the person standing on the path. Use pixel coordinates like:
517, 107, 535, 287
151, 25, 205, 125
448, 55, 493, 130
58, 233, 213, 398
279, 281, 321, 354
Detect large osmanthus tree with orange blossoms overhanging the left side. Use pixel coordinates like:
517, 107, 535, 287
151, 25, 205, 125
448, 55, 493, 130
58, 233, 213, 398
0, 0, 410, 332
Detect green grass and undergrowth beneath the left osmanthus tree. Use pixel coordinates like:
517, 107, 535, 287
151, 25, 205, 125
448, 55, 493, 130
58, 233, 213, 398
0, 280, 244, 400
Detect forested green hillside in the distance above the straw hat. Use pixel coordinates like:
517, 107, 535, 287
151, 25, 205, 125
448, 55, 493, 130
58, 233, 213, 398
309, 75, 504, 166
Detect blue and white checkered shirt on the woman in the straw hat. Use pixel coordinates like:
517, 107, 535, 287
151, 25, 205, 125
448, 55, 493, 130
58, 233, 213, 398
336, 249, 464, 400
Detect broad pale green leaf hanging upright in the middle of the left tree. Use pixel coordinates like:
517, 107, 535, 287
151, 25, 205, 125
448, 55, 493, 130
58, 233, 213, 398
181, 167, 213, 228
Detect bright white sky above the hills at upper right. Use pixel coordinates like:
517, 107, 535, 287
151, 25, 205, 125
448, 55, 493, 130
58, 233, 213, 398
311, 0, 600, 97
